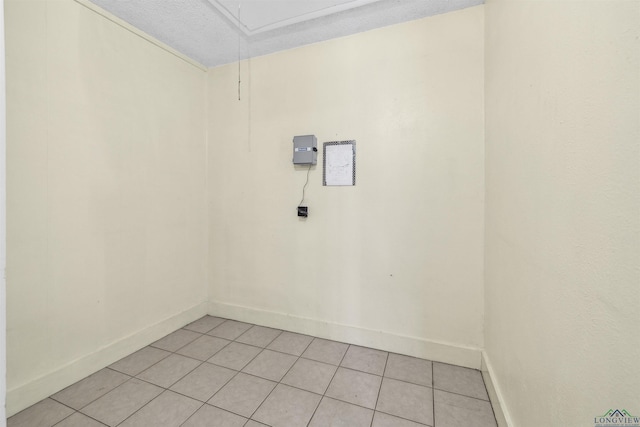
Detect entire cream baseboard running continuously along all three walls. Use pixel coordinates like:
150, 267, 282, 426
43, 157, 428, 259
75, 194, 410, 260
6, 302, 490, 418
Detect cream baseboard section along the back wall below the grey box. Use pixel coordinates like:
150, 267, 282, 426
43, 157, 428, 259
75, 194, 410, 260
209, 301, 482, 369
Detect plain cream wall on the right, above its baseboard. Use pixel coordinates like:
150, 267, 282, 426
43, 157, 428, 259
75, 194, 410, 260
485, 1, 640, 427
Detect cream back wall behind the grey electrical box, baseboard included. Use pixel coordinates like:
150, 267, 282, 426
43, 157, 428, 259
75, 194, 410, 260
209, 7, 484, 367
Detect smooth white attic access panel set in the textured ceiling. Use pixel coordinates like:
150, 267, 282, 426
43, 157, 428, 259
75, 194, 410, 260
209, 0, 379, 36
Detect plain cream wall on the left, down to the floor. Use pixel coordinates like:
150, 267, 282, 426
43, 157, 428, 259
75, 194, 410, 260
5, 0, 207, 415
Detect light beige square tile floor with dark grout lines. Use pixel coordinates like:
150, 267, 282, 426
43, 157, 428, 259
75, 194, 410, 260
8, 316, 496, 427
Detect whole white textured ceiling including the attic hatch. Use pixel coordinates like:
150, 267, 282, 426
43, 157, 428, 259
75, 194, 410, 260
91, 0, 483, 67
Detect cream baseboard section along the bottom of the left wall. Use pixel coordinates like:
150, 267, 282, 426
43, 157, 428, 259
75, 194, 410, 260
6, 302, 209, 417
